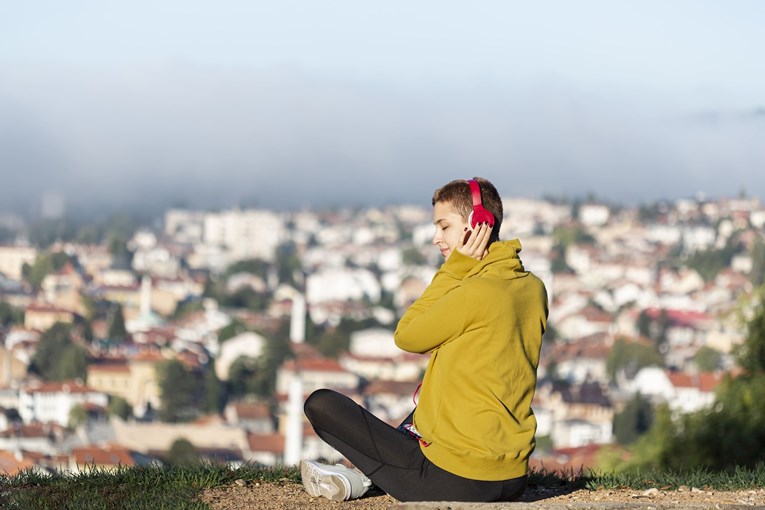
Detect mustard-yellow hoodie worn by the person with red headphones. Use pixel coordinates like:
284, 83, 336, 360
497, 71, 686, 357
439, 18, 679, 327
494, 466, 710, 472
395, 239, 548, 480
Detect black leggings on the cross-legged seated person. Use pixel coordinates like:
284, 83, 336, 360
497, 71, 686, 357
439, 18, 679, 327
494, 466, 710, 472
305, 389, 526, 502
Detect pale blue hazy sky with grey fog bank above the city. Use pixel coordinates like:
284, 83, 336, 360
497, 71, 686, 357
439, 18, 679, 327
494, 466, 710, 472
0, 0, 765, 213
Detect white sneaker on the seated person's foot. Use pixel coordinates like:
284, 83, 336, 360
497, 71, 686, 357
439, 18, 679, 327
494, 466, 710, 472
300, 460, 372, 501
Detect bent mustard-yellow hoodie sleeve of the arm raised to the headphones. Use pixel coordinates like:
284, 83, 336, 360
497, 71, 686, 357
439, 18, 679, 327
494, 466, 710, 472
394, 251, 478, 353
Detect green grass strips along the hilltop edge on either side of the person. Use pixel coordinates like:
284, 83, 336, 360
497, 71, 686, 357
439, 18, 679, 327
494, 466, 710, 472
0, 464, 765, 510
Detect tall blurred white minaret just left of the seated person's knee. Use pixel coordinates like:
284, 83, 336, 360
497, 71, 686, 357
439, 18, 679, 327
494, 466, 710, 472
284, 291, 305, 466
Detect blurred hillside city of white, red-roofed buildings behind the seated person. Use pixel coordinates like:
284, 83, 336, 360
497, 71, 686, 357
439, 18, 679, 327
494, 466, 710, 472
0, 191, 765, 474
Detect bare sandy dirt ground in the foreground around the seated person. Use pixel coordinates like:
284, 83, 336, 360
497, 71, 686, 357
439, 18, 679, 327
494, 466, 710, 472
197, 480, 765, 510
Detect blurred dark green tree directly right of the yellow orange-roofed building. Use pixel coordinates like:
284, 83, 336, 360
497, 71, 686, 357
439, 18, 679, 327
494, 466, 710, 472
156, 359, 202, 423
